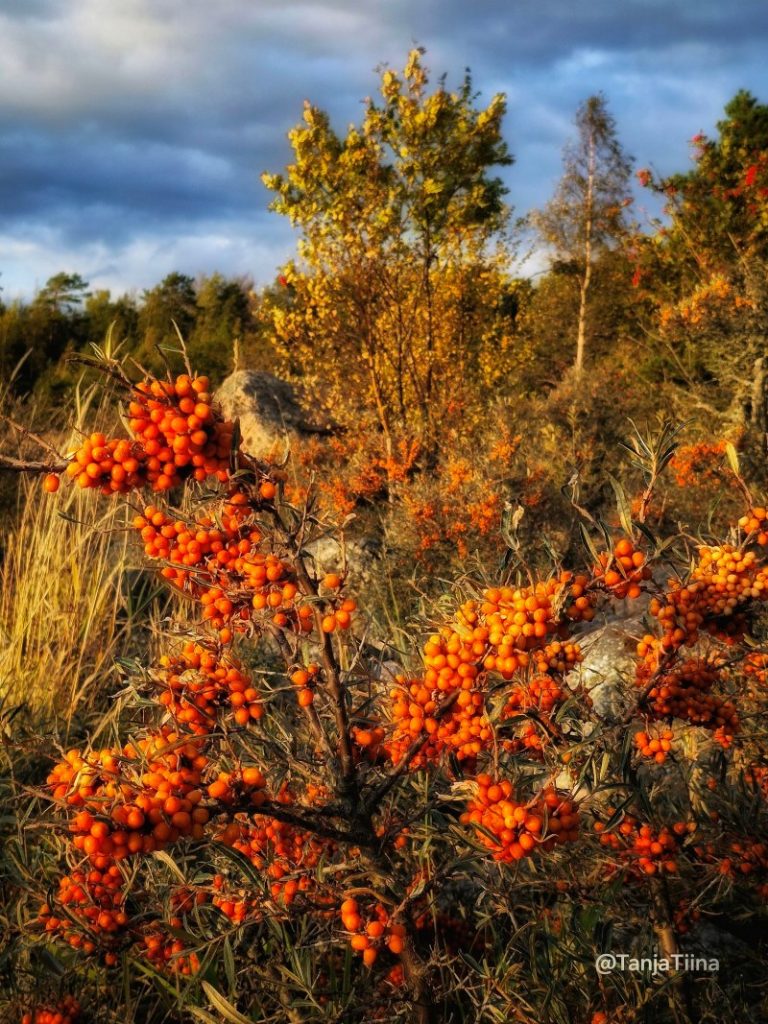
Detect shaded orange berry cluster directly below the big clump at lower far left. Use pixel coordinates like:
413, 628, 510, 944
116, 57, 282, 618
38, 864, 128, 965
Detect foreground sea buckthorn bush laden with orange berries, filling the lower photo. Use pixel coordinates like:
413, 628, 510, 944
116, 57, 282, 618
3, 362, 768, 1024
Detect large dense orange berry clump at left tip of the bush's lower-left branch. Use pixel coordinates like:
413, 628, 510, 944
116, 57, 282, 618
48, 727, 210, 870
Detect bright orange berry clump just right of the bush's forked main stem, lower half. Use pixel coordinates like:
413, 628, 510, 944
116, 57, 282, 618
460, 775, 579, 862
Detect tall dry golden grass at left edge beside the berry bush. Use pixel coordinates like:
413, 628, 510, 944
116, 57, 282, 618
0, 380, 159, 727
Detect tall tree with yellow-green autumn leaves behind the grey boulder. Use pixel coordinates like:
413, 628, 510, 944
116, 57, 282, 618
263, 49, 515, 452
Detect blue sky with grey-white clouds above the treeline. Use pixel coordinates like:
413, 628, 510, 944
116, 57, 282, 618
0, 0, 768, 301
